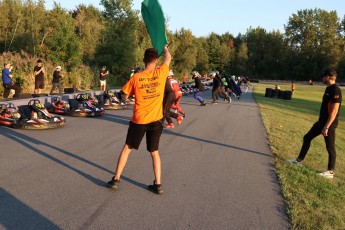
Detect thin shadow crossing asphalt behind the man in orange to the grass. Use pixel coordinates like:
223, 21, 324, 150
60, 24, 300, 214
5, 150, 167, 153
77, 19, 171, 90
98, 114, 272, 157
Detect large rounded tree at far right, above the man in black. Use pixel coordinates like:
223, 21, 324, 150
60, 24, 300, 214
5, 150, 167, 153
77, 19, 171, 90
285, 9, 343, 80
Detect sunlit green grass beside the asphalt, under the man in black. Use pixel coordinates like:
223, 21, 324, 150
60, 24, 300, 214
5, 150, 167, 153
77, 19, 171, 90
254, 83, 345, 229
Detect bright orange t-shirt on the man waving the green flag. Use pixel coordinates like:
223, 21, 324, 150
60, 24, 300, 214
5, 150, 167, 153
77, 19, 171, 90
122, 64, 169, 124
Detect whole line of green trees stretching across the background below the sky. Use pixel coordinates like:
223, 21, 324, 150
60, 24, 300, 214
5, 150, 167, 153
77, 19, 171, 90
0, 0, 345, 91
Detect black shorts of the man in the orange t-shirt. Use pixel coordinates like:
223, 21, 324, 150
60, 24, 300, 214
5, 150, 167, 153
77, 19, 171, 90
126, 121, 163, 152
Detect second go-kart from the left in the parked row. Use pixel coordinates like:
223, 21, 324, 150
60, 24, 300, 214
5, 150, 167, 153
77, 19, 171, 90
47, 94, 104, 117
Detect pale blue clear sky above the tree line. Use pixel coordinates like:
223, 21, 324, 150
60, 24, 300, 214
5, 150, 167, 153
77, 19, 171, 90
46, 0, 345, 37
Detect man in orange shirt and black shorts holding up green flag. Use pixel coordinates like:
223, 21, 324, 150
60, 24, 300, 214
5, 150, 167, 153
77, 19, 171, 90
107, 46, 171, 194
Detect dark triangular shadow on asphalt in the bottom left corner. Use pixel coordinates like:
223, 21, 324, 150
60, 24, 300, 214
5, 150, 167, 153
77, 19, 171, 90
0, 188, 60, 230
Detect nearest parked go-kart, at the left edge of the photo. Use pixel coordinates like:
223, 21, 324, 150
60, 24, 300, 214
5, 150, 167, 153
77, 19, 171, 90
0, 99, 66, 129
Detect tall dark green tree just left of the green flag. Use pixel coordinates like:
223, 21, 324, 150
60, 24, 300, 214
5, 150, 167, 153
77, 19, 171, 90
95, 0, 139, 84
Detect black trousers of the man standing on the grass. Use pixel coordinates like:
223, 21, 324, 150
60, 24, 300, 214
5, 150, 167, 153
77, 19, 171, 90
297, 122, 337, 170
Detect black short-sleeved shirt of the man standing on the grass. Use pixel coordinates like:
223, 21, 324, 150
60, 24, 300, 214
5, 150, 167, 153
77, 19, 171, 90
319, 84, 342, 127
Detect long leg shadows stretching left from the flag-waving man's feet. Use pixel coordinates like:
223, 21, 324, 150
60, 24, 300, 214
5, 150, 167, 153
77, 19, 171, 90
0, 128, 147, 190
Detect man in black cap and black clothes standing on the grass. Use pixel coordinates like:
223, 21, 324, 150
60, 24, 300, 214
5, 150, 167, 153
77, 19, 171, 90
289, 69, 342, 178
